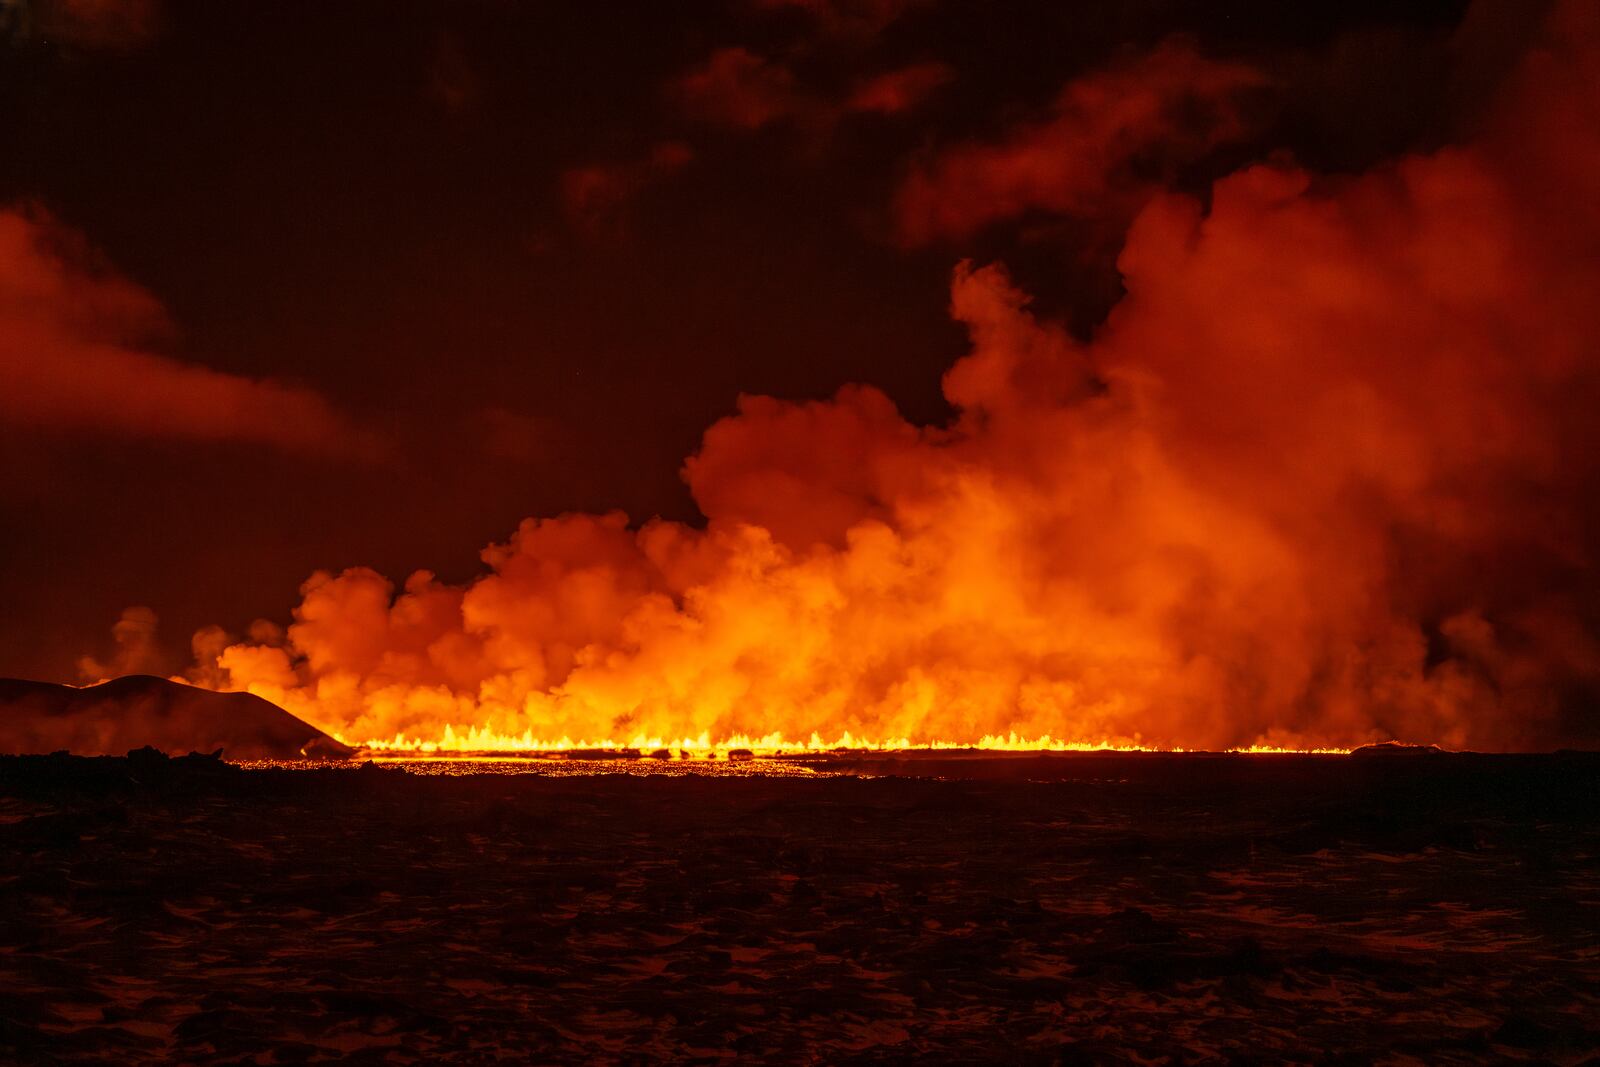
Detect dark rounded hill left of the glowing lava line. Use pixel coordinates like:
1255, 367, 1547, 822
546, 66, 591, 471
0, 675, 355, 760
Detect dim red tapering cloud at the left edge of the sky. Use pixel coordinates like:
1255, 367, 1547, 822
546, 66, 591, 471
0, 208, 376, 456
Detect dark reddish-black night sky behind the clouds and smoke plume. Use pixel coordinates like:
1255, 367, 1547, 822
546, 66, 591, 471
0, 0, 1515, 680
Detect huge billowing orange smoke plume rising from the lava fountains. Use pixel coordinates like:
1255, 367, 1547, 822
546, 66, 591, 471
193, 5, 1600, 747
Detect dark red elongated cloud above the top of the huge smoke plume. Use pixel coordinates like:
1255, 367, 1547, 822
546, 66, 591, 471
894, 42, 1264, 245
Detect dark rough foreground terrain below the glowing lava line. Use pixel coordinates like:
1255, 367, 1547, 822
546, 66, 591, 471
0, 753, 1600, 1064
